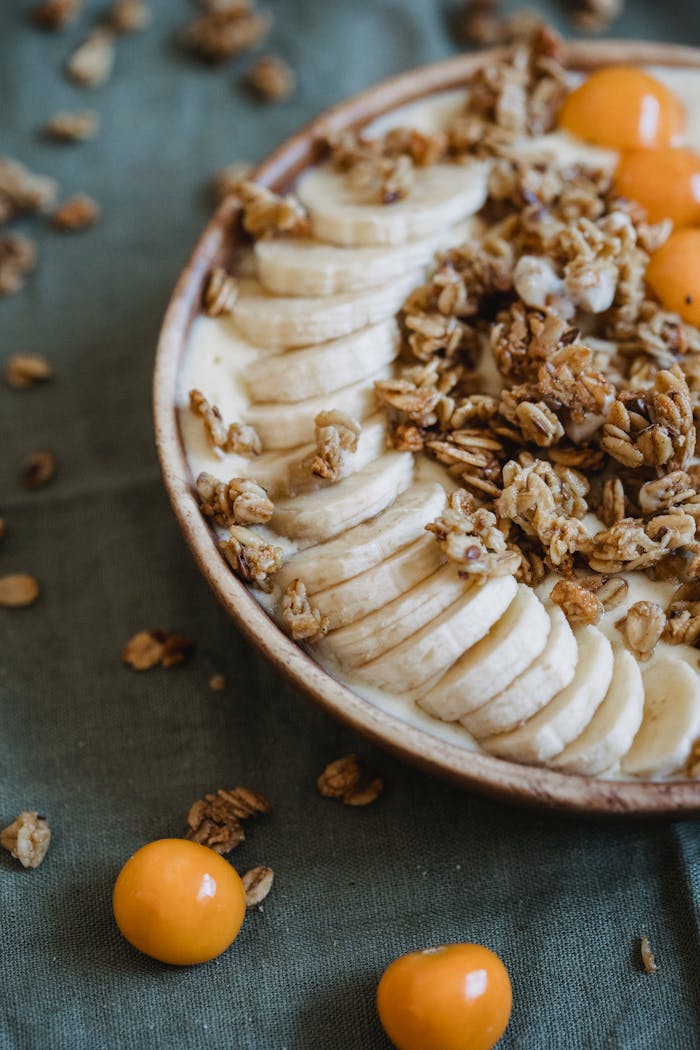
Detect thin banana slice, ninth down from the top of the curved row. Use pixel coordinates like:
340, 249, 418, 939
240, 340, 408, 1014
312, 536, 442, 630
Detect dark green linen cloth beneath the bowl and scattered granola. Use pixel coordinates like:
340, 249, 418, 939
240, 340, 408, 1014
0, 0, 700, 1050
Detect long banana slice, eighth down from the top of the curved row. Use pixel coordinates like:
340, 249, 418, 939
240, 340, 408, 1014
276, 482, 445, 594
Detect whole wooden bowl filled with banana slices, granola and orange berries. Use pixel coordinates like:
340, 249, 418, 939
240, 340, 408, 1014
154, 30, 700, 814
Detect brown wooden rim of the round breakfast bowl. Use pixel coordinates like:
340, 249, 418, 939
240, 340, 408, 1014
153, 41, 700, 816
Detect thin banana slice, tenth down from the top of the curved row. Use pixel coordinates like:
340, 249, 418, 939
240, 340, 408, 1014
317, 565, 471, 668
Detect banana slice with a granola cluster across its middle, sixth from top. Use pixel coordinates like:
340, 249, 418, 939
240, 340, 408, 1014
252, 416, 386, 500
